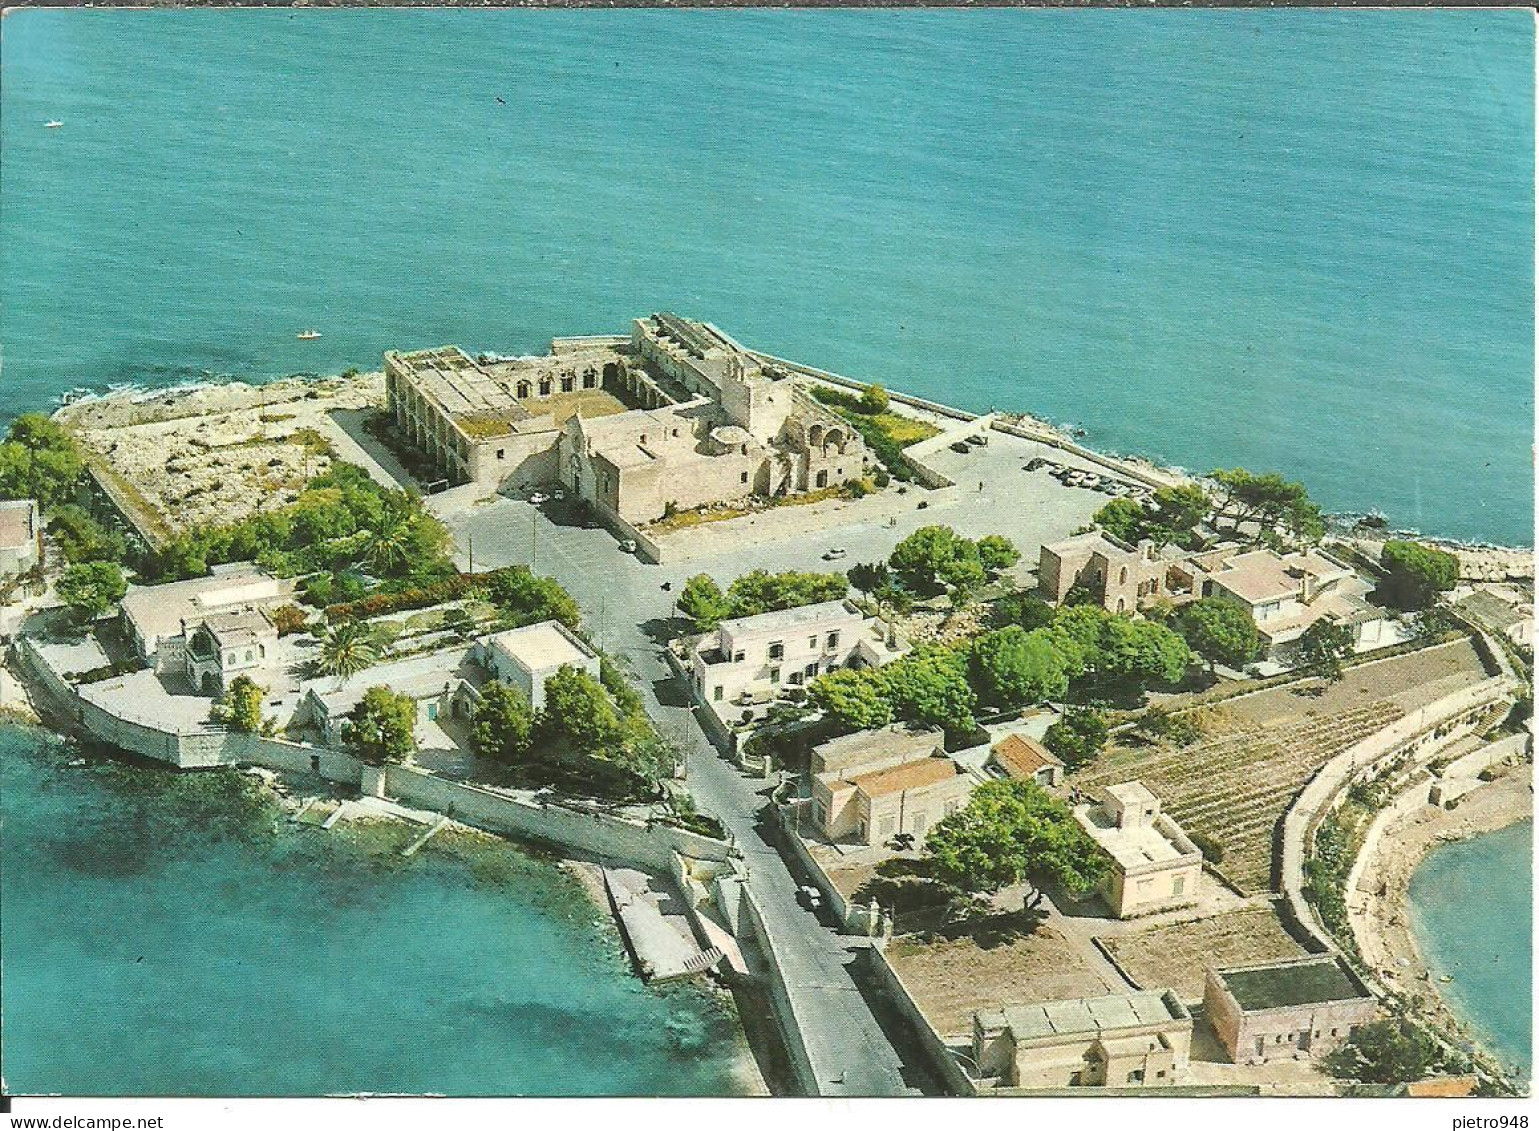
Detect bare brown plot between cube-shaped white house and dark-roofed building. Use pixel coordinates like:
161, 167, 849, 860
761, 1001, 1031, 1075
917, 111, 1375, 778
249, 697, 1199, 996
1102, 906, 1305, 1002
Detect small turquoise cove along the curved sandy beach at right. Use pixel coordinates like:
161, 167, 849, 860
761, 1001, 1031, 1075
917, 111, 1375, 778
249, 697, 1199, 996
1410, 820, 1534, 1076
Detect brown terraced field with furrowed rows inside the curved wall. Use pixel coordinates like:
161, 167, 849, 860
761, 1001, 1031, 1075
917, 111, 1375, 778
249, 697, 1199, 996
1068, 700, 1405, 892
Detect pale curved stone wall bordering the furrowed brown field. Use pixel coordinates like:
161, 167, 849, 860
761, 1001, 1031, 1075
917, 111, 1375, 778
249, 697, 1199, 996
1282, 676, 1513, 953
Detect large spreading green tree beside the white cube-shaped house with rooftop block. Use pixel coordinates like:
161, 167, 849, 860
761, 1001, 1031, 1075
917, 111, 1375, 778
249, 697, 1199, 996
925, 780, 1107, 906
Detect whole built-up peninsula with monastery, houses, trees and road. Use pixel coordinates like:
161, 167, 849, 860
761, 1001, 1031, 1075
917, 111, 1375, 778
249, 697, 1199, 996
0, 312, 1533, 1096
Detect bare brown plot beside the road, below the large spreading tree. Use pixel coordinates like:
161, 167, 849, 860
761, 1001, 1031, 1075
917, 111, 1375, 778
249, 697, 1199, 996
886, 926, 1120, 1037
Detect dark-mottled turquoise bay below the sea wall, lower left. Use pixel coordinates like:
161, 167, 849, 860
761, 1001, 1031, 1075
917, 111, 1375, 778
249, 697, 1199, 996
0, 726, 742, 1096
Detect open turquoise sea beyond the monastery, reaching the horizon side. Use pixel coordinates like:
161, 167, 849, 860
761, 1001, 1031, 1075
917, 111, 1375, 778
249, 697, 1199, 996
0, 11, 1534, 543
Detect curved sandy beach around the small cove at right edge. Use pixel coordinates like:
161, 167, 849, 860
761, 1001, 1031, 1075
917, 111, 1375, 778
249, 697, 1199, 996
1348, 765, 1533, 1058
